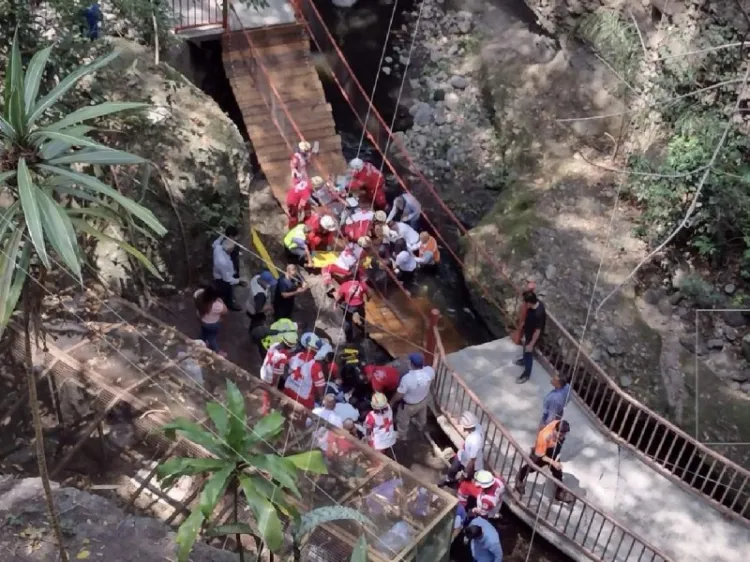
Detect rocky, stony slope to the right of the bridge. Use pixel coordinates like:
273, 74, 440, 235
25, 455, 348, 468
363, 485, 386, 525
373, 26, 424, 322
388, 0, 750, 462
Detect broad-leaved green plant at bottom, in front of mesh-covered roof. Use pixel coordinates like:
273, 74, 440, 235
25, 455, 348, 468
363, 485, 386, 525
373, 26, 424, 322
157, 381, 369, 562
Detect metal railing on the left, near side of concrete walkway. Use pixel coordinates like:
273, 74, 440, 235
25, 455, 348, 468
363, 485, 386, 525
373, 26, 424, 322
432, 328, 671, 562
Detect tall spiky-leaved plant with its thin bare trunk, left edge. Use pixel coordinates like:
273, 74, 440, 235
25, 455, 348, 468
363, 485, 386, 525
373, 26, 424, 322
0, 33, 166, 562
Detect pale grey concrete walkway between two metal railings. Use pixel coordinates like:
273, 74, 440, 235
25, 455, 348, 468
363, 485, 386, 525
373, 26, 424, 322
447, 338, 750, 562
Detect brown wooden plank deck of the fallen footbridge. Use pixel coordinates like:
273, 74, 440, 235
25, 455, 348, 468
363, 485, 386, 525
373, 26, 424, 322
222, 24, 466, 357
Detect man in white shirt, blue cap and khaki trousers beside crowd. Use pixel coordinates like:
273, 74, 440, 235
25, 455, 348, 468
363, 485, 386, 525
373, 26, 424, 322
391, 353, 435, 441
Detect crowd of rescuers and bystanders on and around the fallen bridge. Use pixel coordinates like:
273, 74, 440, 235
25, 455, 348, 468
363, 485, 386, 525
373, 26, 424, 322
195, 142, 570, 562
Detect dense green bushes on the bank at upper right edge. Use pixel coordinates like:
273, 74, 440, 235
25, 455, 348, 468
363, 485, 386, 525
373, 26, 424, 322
580, 10, 750, 276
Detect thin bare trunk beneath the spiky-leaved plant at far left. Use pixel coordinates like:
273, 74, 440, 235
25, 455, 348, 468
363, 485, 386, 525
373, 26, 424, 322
23, 294, 69, 562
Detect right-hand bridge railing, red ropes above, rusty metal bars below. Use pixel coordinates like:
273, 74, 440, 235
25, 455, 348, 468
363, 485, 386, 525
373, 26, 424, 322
293, 0, 750, 523
